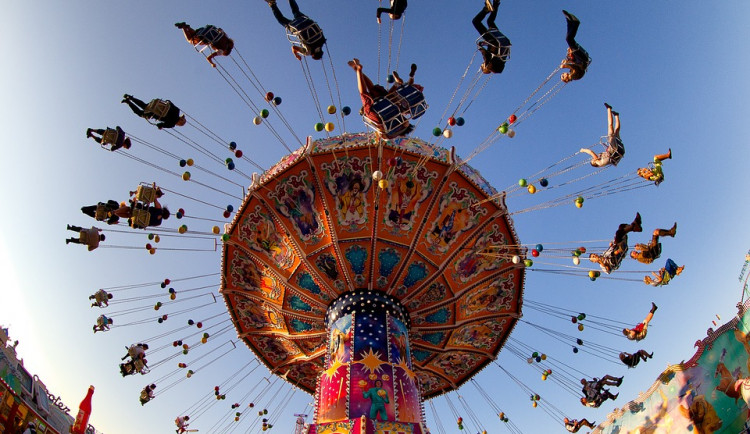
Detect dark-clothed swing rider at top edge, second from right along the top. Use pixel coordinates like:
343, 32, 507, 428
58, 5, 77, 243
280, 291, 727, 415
471, 0, 511, 74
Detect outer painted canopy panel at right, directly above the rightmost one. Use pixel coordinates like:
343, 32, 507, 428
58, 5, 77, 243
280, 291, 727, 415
444, 222, 513, 292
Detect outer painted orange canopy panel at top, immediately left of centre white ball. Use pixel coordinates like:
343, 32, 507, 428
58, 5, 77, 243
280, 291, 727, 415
312, 149, 377, 240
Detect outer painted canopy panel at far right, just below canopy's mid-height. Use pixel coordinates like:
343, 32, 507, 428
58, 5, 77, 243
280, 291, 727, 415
456, 272, 521, 322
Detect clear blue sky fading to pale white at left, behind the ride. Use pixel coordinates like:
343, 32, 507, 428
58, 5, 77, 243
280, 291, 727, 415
0, 0, 750, 434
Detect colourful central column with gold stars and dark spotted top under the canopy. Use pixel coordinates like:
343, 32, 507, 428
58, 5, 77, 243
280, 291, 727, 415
309, 290, 425, 434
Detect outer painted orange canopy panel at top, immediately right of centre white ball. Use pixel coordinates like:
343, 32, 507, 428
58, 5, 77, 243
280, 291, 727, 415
377, 148, 445, 245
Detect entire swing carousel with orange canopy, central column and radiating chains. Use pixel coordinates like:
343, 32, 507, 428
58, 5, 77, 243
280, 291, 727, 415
70, 1, 692, 434
